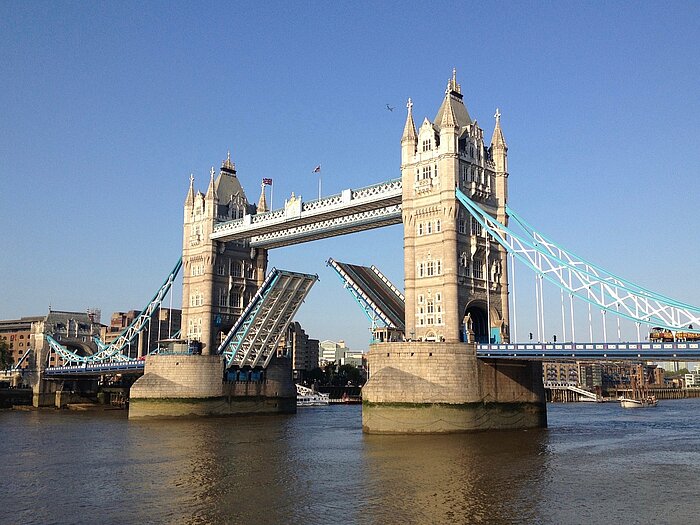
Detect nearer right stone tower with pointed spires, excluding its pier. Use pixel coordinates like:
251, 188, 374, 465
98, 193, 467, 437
401, 71, 508, 343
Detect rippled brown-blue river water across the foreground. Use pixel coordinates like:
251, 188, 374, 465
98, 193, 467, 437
0, 399, 700, 525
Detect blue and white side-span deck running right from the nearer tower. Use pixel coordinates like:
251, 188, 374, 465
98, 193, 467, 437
476, 342, 700, 361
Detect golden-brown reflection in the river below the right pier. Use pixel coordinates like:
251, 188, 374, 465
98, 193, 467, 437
364, 431, 547, 523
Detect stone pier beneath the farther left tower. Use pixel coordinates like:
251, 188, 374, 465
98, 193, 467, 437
129, 354, 296, 419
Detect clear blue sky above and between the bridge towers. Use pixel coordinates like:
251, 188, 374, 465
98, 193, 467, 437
0, 1, 700, 349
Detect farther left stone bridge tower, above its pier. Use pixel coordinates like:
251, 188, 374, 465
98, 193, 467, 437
181, 153, 267, 354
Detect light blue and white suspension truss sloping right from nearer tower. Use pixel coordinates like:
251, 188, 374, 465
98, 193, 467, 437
455, 188, 700, 334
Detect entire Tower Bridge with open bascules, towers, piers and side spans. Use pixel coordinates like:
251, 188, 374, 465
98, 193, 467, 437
20, 71, 700, 433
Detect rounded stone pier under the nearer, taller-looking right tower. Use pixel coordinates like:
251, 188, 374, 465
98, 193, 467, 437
362, 342, 547, 434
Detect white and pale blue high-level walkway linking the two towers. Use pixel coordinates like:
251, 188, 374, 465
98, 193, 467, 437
210, 179, 402, 248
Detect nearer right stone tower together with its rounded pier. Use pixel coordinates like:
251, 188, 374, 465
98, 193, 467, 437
362, 71, 547, 434
